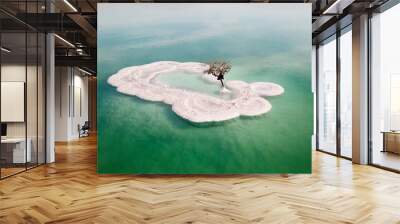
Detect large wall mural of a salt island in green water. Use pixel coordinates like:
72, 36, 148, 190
97, 3, 313, 174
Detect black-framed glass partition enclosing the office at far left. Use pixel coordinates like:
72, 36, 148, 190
0, 5, 46, 179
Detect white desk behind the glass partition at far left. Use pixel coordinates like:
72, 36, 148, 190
1, 138, 32, 163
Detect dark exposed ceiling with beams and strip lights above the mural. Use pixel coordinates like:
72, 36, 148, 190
0, 0, 394, 73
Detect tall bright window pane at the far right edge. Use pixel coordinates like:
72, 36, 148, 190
371, 5, 400, 170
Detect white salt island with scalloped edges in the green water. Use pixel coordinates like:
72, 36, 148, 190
108, 61, 284, 123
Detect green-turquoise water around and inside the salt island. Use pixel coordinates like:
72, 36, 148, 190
98, 4, 313, 174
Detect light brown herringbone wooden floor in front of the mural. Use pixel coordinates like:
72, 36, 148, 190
0, 137, 400, 224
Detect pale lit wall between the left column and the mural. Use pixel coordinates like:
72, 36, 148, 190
55, 67, 88, 141
